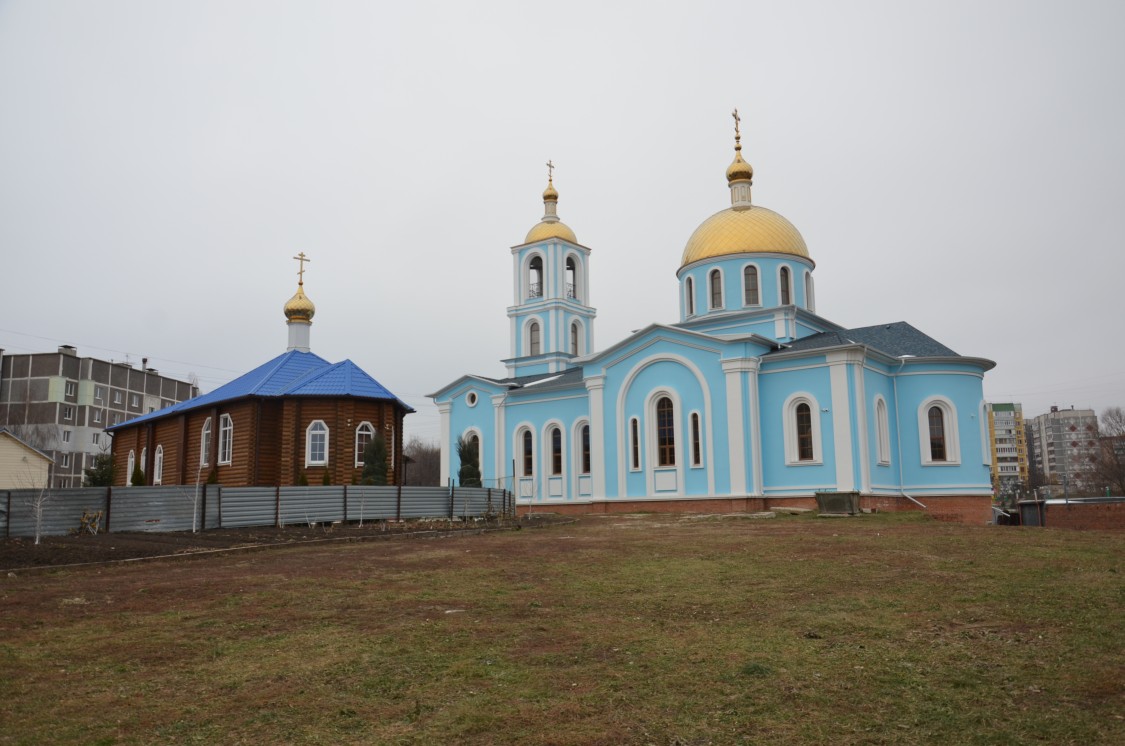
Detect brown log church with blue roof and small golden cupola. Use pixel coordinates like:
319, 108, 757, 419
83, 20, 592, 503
107, 259, 414, 487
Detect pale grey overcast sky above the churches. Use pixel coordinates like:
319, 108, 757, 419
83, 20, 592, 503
0, 0, 1125, 438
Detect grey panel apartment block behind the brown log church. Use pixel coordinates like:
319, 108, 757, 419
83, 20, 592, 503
0, 344, 199, 487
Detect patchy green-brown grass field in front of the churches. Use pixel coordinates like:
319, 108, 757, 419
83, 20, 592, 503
0, 514, 1125, 745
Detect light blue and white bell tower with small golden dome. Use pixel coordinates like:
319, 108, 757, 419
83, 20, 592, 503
504, 161, 597, 376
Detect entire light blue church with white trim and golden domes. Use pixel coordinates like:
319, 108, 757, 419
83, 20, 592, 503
431, 115, 995, 522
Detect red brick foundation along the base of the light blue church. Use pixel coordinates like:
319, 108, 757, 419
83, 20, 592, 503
516, 495, 994, 525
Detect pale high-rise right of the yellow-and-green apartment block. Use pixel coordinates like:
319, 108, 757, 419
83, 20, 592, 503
1029, 406, 1100, 491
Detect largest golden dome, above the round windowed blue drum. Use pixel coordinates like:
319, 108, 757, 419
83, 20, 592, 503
681, 207, 809, 267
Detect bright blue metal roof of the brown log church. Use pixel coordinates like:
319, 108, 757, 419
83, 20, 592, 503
106, 350, 414, 431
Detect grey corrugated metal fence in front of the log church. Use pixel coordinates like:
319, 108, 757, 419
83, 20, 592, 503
0, 485, 515, 537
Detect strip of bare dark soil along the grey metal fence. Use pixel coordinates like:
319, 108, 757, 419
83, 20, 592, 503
0, 513, 573, 570
